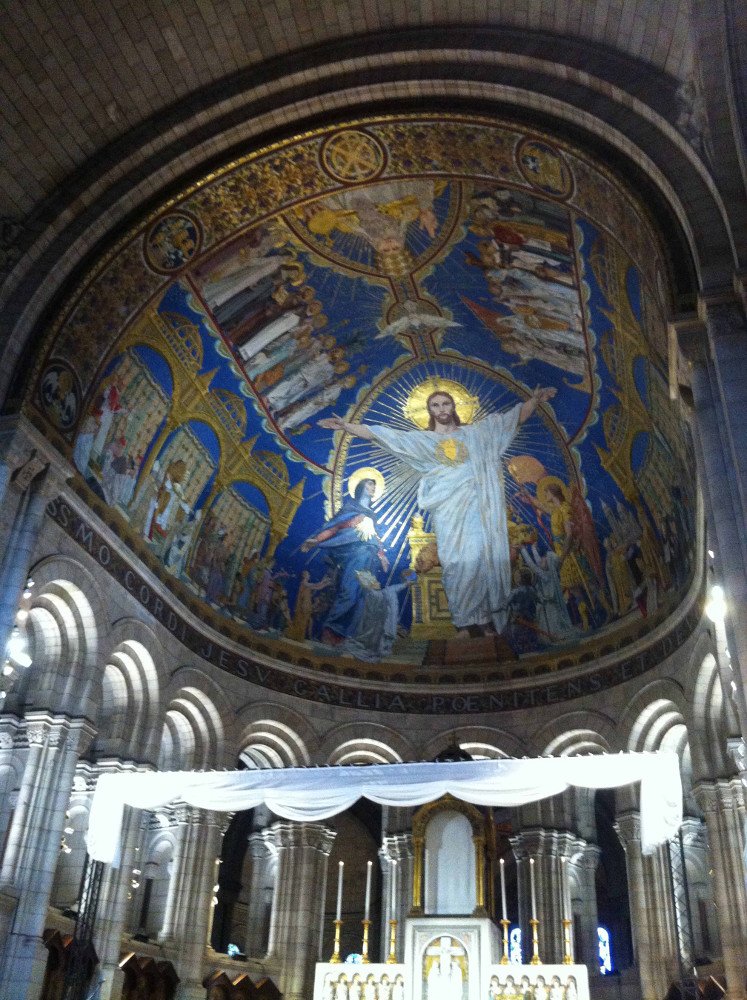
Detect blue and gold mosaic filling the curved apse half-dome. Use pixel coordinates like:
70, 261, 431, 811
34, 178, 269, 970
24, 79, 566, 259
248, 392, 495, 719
27, 116, 695, 682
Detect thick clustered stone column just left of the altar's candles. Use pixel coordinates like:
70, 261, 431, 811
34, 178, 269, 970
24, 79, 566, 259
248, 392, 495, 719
268, 820, 335, 1000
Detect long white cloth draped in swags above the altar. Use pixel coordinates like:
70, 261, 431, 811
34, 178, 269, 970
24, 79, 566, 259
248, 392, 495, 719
87, 751, 682, 864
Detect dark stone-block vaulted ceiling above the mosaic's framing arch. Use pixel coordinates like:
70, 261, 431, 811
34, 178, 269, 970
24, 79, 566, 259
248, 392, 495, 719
0, 0, 700, 217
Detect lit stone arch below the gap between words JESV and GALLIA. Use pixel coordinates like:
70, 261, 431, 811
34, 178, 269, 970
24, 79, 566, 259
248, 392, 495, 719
236, 702, 317, 767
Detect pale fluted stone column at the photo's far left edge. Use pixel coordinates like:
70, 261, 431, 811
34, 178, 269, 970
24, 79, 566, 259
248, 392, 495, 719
0, 712, 94, 1000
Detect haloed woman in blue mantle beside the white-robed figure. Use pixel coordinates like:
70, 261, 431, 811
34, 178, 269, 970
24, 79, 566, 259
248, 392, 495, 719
301, 468, 389, 646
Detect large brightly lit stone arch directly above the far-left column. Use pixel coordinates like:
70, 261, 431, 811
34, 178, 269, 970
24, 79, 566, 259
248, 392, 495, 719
21, 556, 108, 717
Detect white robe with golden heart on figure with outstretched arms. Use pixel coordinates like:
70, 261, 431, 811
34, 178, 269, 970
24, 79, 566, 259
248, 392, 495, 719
369, 403, 521, 632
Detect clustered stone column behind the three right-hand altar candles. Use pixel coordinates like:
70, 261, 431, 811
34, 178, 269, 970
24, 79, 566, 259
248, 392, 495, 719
510, 828, 580, 964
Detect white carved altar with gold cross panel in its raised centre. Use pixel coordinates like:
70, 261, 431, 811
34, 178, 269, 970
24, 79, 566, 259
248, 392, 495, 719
314, 916, 589, 1000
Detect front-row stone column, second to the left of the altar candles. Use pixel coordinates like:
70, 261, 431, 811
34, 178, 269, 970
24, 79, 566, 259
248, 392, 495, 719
159, 806, 228, 1000
